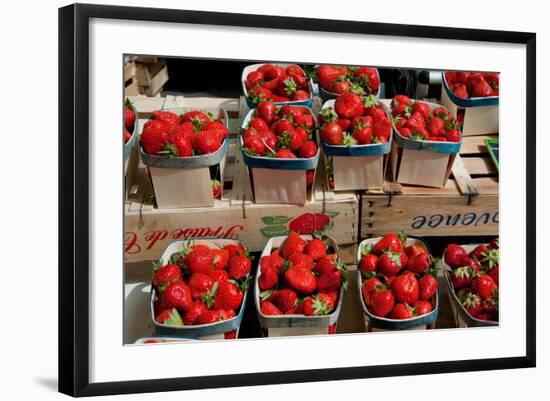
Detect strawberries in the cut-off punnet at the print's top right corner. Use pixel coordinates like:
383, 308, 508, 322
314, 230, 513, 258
445, 71, 499, 99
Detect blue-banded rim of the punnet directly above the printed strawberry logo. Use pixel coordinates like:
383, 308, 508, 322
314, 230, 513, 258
239, 103, 321, 170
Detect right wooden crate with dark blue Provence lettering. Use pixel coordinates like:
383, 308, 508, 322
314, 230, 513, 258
359, 131, 499, 238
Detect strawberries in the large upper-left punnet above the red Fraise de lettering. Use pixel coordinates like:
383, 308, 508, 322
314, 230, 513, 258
141, 110, 229, 157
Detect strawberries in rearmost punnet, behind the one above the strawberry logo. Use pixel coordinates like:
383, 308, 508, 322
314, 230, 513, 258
244, 64, 311, 103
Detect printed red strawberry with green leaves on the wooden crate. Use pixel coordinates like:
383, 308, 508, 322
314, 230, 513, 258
260, 212, 339, 238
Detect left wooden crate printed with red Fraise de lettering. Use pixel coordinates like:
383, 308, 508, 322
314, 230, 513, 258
124, 96, 359, 263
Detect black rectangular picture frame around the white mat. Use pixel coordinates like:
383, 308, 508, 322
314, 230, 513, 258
59, 4, 536, 396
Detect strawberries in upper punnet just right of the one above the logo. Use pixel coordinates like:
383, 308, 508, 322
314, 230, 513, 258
319, 92, 392, 146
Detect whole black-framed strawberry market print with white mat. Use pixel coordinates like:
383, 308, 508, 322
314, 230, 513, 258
59, 4, 536, 396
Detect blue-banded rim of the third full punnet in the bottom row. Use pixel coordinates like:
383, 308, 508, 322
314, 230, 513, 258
357, 236, 439, 330
